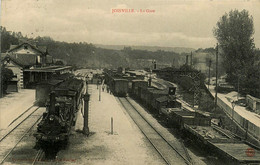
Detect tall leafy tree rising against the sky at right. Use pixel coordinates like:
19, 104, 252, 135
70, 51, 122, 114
213, 10, 255, 84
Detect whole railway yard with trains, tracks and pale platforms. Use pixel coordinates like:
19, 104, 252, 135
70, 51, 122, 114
0, 71, 260, 165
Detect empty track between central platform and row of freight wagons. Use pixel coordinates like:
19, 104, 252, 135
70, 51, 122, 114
118, 97, 193, 165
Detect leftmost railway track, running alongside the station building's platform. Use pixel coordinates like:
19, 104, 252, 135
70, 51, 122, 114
0, 107, 45, 164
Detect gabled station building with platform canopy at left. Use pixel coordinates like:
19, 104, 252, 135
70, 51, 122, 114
1, 42, 72, 91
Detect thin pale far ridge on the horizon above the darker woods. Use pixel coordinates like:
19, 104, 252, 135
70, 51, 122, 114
94, 44, 195, 53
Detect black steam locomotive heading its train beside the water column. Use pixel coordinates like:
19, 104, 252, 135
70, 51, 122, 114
34, 78, 86, 144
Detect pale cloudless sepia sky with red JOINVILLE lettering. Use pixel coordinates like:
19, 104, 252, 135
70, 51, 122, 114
1, 0, 260, 49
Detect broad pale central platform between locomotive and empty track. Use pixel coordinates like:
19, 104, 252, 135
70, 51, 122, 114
55, 85, 165, 165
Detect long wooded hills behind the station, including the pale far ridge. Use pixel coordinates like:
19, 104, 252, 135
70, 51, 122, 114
0, 27, 189, 69
